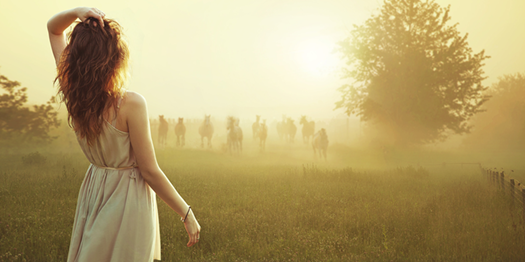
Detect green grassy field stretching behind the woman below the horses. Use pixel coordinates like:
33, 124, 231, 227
0, 145, 525, 261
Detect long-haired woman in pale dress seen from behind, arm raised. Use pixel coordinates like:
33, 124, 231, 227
47, 7, 201, 262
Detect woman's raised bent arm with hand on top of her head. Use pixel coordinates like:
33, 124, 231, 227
47, 7, 106, 65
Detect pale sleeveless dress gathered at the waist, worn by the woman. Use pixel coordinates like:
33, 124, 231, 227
67, 101, 160, 262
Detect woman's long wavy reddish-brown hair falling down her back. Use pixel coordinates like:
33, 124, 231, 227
55, 18, 129, 145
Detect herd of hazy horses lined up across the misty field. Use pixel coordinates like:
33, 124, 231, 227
158, 115, 328, 160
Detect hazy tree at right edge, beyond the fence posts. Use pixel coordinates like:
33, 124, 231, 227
464, 73, 525, 152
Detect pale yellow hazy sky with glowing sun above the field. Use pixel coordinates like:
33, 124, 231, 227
0, 0, 525, 119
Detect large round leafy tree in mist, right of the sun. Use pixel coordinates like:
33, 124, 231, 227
336, 0, 488, 145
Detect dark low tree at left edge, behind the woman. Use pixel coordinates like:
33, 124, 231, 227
0, 72, 60, 146
